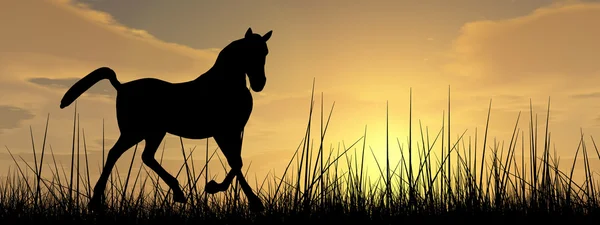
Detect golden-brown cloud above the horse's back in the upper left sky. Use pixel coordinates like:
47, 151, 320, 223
0, 0, 217, 80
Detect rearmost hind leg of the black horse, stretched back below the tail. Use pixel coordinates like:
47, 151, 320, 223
88, 133, 142, 210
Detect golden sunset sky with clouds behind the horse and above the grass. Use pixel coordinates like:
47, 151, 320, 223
0, 0, 600, 186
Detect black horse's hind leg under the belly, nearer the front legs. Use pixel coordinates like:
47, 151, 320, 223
142, 133, 186, 203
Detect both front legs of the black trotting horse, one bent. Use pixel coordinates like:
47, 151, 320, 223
204, 132, 264, 211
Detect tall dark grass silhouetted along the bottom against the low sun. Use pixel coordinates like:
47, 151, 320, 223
0, 83, 600, 224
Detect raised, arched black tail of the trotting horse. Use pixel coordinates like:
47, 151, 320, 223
60, 67, 121, 109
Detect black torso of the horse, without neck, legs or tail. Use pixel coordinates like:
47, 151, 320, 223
117, 78, 253, 138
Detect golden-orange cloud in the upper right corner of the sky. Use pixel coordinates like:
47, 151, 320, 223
446, 3, 600, 92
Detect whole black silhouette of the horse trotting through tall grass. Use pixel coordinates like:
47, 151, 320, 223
60, 28, 273, 211
